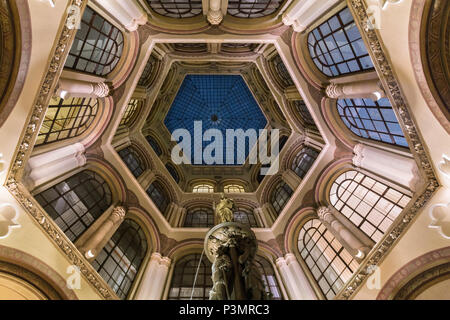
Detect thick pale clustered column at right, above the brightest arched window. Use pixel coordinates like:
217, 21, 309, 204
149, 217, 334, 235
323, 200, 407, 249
353, 143, 420, 191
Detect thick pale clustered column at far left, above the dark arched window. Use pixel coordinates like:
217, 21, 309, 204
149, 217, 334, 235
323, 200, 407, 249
24, 143, 86, 190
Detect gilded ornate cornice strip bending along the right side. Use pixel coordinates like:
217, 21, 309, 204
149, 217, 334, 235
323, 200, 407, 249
336, 0, 439, 299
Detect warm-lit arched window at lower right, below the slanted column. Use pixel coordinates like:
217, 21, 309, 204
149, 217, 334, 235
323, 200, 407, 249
298, 219, 359, 299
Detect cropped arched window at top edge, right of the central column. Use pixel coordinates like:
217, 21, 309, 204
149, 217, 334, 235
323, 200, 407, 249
228, 0, 284, 18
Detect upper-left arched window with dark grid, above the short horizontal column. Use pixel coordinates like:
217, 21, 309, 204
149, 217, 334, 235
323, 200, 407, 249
65, 7, 123, 77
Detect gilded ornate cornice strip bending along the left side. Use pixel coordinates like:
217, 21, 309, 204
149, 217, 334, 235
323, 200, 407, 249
5, 0, 118, 299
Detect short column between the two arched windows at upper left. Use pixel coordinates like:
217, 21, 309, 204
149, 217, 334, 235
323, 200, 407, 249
56, 79, 109, 99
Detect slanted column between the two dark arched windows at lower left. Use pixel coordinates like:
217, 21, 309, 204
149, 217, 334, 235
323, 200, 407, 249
81, 206, 126, 260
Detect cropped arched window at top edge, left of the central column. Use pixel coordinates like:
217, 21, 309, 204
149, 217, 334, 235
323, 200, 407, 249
147, 0, 202, 18
